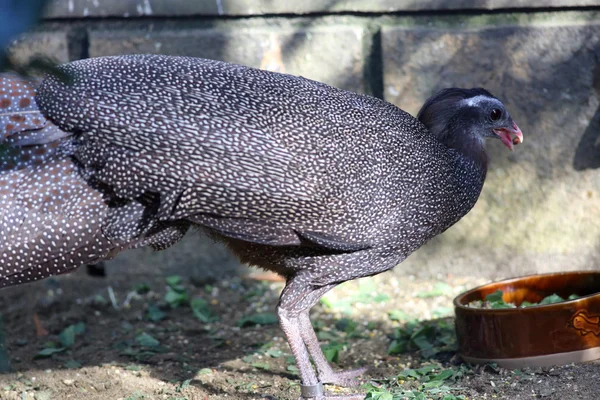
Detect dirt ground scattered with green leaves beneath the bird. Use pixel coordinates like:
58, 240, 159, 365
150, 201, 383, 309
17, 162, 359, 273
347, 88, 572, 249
0, 262, 600, 400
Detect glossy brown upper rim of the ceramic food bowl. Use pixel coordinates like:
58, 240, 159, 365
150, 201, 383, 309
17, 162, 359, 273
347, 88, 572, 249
452, 270, 600, 315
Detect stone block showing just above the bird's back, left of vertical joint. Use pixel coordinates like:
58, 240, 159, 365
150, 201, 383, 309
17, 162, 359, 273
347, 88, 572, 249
89, 26, 365, 92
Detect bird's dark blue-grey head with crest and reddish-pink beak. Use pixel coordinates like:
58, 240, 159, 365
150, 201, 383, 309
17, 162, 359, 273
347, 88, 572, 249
417, 88, 523, 150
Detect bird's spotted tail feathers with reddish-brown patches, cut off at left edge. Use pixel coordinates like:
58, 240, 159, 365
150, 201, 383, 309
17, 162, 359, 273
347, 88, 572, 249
0, 74, 122, 287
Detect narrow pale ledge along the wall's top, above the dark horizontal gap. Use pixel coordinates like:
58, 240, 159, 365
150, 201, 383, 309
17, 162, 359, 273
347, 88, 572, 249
46, 0, 600, 18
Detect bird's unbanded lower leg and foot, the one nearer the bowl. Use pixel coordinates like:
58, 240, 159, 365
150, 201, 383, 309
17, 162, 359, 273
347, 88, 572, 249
298, 311, 367, 387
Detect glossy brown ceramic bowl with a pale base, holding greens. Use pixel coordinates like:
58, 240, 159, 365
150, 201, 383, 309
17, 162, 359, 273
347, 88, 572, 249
454, 271, 600, 368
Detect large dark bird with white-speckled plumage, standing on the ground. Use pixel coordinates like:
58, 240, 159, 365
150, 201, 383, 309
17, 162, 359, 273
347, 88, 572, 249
0, 55, 523, 400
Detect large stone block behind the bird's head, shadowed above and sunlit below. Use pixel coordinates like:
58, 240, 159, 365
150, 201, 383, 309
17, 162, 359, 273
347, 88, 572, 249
382, 23, 600, 276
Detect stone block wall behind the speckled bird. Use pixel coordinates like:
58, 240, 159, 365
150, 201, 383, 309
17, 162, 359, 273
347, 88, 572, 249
8, 0, 600, 278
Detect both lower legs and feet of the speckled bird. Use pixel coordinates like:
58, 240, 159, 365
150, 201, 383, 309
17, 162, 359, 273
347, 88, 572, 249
277, 276, 364, 400
